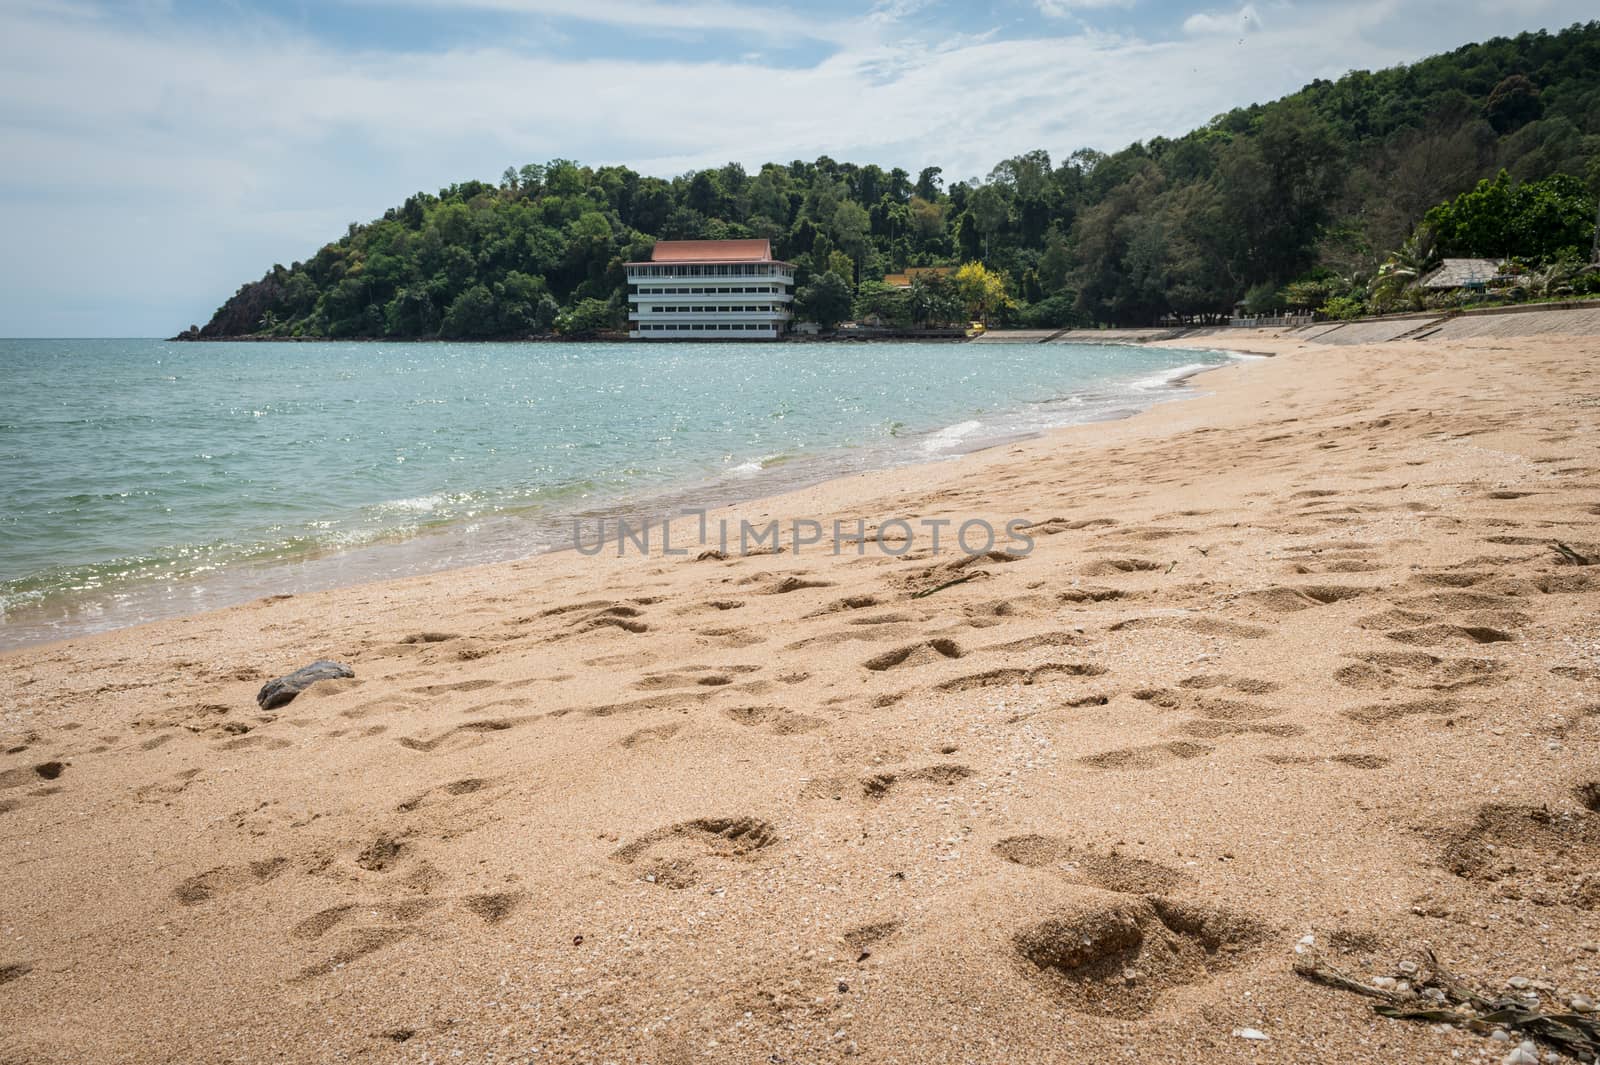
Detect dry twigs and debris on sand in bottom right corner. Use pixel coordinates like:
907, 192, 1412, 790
1294, 948, 1600, 1065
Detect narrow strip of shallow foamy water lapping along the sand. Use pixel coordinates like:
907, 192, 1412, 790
0, 345, 1245, 654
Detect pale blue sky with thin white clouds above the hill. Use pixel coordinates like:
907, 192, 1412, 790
0, 0, 1594, 337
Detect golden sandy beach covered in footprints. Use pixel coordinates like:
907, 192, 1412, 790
0, 323, 1600, 1065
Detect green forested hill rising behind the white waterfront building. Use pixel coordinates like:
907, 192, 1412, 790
178, 22, 1600, 337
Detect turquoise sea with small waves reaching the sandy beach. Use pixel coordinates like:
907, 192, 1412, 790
0, 341, 1229, 648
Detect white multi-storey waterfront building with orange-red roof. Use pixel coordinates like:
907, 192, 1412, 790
627, 240, 795, 341
